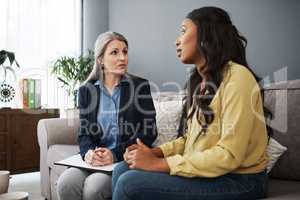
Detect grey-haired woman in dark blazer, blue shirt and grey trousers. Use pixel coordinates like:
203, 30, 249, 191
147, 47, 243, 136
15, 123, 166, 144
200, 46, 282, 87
57, 32, 157, 200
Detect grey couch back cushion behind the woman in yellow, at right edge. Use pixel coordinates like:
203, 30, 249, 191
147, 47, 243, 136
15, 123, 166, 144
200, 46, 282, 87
264, 80, 300, 180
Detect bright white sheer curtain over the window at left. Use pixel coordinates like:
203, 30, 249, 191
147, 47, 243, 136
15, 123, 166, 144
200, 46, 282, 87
0, 0, 81, 108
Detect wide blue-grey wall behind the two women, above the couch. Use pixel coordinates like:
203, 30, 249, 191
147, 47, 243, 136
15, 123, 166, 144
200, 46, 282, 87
85, 0, 300, 90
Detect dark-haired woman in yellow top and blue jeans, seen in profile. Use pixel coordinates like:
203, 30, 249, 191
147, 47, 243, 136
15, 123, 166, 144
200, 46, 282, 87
113, 7, 268, 200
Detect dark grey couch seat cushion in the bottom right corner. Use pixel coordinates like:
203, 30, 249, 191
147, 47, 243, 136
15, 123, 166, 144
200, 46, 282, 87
267, 179, 300, 200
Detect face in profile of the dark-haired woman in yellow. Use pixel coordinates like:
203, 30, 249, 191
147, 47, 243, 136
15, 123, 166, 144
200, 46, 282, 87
175, 19, 200, 64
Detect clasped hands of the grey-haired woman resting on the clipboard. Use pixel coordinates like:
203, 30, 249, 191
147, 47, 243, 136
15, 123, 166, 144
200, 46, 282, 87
84, 147, 114, 167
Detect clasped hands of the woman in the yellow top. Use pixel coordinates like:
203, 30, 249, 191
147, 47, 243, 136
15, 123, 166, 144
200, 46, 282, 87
124, 139, 170, 172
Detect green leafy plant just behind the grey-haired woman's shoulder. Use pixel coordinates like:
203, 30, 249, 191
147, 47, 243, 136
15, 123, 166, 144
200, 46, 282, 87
52, 50, 94, 107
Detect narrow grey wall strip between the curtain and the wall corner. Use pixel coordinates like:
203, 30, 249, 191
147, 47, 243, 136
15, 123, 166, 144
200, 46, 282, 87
82, 0, 109, 52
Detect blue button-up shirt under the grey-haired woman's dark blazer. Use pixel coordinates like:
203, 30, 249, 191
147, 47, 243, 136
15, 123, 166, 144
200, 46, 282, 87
95, 80, 121, 149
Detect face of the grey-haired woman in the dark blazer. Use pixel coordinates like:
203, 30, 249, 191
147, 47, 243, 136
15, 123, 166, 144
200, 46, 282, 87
98, 40, 128, 75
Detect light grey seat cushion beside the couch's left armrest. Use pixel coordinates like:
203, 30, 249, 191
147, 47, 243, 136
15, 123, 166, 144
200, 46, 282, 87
47, 144, 79, 175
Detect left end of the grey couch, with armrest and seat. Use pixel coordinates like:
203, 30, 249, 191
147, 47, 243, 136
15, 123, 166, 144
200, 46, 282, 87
38, 118, 79, 200
